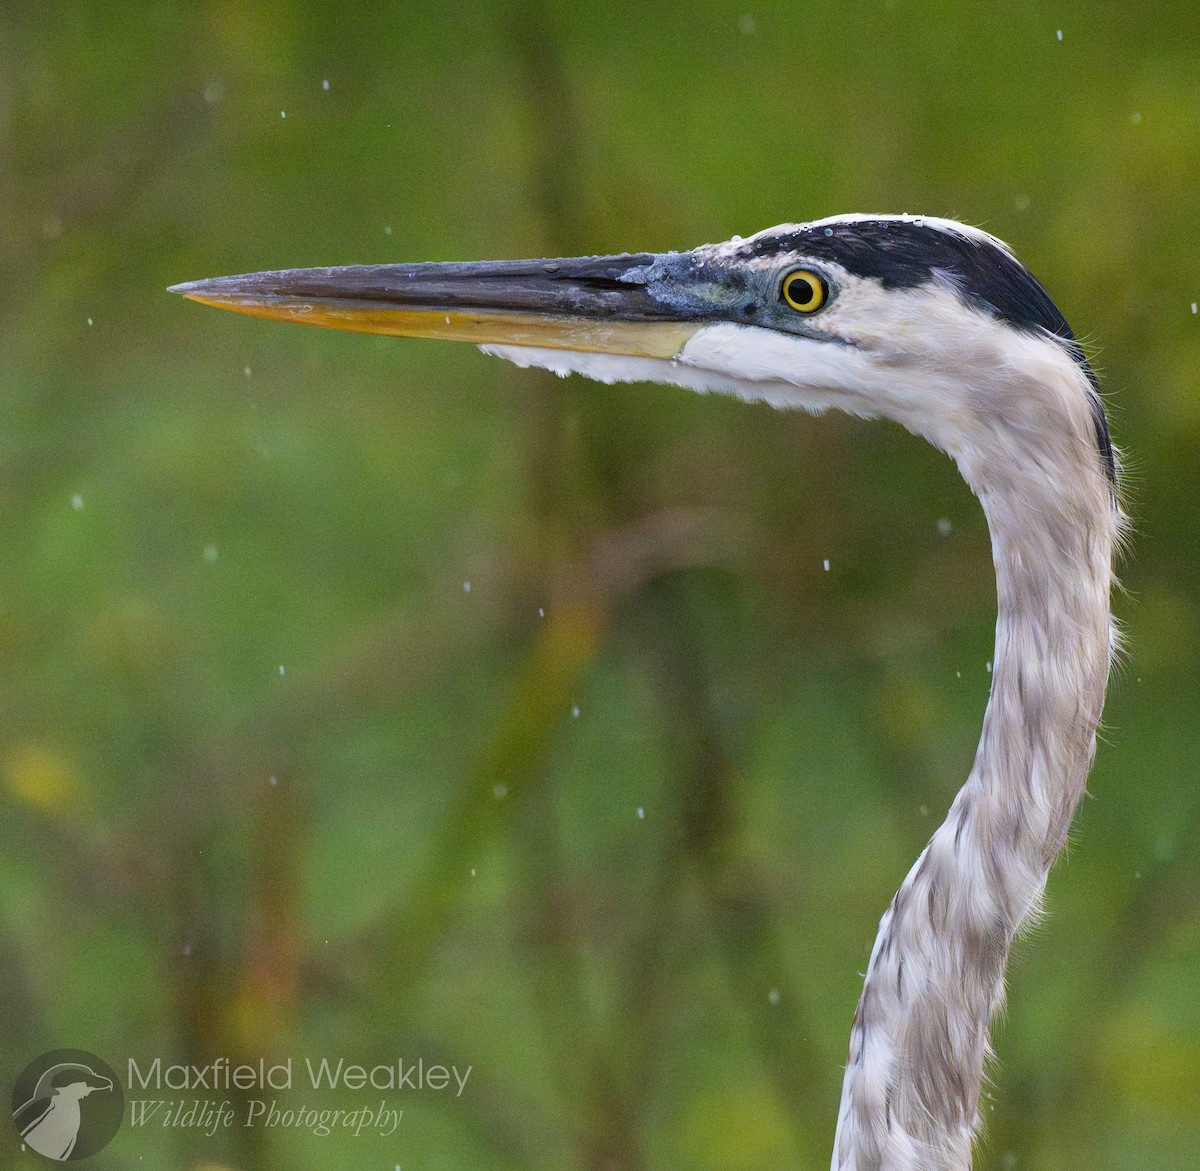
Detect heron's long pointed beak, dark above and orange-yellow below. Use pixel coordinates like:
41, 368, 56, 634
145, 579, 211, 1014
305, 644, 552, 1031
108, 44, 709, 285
169, 253, 703, 359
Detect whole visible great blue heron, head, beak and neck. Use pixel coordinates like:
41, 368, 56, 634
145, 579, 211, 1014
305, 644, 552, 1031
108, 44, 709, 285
175, 216, 1122, 1171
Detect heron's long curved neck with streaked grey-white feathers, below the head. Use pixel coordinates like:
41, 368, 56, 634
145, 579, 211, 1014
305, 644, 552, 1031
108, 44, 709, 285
833, 449, 1118, 1171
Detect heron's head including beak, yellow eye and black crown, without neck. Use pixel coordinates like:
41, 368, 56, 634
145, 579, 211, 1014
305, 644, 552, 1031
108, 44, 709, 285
174, 216, 1115, 494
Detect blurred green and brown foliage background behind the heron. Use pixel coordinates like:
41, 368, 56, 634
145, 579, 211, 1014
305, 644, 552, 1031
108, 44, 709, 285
0, 0, 1200, 1171
